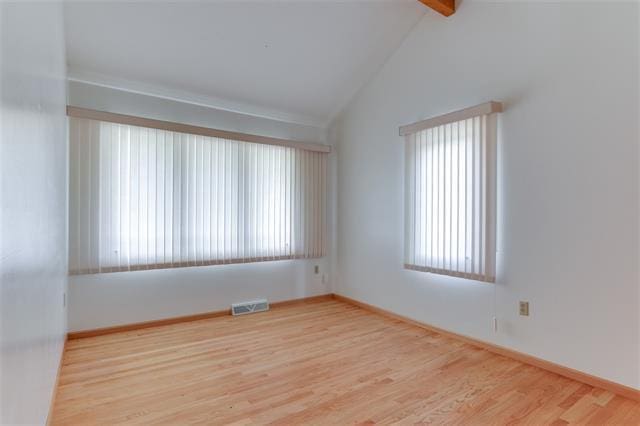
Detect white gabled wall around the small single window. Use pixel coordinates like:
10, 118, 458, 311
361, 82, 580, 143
333, 0, 640, 388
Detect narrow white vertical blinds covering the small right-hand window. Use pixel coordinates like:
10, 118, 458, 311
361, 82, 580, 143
405, 114, 496, 282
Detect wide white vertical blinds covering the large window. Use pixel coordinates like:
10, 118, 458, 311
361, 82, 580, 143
69, 117, 327, 274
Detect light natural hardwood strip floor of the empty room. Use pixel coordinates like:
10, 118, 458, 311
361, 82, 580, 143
52, 299, 640, 425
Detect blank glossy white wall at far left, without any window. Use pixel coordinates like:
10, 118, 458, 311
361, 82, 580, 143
0, 2, 67, 424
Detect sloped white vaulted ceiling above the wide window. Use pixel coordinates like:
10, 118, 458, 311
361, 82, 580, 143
65, 0, 426, 126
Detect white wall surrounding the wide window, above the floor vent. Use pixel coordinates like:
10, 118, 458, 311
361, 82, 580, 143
69, 81, 335, 331
